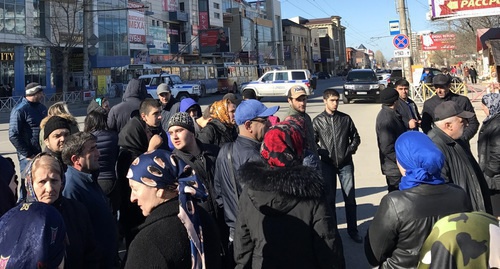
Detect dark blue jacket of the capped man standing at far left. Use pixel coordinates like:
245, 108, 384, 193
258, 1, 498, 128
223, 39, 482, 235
9, 97, 47, 160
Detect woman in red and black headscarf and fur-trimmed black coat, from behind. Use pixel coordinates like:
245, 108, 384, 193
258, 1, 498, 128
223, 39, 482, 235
234, 121, 345, 269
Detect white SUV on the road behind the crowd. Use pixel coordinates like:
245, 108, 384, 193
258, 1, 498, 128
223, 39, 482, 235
241, 69, 314, 99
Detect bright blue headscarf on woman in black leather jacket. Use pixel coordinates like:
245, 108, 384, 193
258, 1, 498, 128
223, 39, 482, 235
395, 131, 445, 190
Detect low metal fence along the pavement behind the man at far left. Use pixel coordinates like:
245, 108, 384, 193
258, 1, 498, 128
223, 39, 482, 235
0, 91, 83, 112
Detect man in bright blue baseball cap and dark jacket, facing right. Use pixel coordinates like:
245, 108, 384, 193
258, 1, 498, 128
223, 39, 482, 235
215, 99, 280, 251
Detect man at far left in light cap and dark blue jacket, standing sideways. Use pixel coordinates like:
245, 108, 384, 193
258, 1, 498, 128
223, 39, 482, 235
9, 82, 47, 199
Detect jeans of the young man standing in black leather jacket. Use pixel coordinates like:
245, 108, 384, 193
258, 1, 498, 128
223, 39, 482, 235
321, 160, 358, 235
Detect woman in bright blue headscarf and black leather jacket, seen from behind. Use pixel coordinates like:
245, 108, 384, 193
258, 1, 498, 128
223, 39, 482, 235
365, 131, 472, 268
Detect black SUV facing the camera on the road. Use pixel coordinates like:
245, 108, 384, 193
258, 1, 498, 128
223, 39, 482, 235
342, 69, 381, 104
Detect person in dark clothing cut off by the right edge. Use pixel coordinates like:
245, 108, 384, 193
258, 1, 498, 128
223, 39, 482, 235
477, 93, 500, 217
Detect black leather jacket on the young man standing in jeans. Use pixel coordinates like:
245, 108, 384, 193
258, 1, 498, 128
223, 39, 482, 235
313, 111, 361, 167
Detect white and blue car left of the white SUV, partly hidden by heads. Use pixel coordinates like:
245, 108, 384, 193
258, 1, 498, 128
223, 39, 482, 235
139, 73, 201, 101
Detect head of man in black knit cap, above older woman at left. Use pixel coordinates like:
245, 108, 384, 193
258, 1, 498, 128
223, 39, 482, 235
43, 116, 71, 172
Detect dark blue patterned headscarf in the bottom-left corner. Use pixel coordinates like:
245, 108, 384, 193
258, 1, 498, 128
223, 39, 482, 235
0, 202, 67, 269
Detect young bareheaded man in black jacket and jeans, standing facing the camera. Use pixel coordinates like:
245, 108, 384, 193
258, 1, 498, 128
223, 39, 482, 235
313, 89, 363, 243
